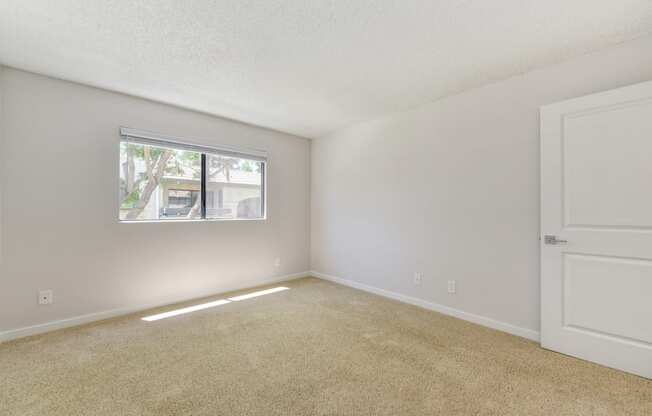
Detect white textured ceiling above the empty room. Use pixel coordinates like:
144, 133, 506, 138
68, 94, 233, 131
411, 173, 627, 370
0, 0, 652, 137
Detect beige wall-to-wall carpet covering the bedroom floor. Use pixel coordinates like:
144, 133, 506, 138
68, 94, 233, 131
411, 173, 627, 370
0, 278, 652, 416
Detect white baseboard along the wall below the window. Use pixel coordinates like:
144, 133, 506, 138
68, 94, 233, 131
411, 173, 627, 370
0, 272, 310, 343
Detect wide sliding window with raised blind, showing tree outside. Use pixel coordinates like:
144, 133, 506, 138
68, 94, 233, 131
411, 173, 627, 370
120, 128, 266, 221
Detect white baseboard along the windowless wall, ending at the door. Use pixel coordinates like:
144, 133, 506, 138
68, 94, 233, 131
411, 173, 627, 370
310, 271, 539, 342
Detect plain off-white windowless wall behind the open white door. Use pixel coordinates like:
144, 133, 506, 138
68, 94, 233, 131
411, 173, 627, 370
311, 37, 652, 332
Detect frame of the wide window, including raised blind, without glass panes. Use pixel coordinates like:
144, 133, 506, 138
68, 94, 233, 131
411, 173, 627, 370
118, 127, 269, 224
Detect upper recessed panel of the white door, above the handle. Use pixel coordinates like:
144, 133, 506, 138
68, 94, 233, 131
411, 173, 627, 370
562, 101, 652, 228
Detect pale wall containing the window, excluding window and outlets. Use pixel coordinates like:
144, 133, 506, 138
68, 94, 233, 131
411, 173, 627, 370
0, 68, 310, 332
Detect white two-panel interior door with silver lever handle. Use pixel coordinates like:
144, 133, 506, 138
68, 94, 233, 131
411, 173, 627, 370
541, 82, 652, 378
